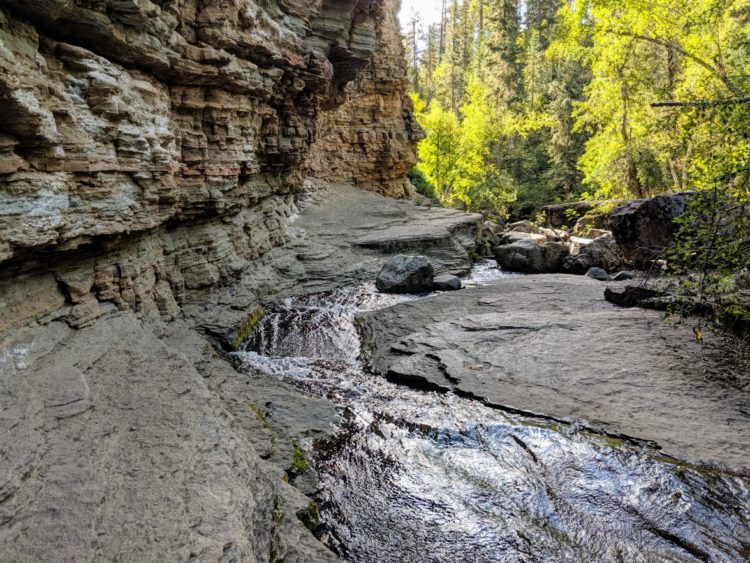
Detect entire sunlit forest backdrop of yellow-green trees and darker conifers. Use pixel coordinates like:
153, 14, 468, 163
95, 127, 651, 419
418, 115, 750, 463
410, 0, 750, 215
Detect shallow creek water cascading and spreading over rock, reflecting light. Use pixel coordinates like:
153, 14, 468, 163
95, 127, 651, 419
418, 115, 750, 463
239, 263, 750, 562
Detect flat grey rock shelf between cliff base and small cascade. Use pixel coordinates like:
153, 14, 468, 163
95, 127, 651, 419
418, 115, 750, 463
189, 184, 481, 342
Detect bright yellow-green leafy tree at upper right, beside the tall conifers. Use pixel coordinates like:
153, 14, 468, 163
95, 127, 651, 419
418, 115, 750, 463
550, 0, 750, 197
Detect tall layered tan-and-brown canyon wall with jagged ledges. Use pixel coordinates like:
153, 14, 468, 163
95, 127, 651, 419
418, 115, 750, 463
0, 0, 417, 332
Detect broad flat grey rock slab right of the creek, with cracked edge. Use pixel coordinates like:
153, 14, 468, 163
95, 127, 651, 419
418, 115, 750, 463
361, 275, 750, 471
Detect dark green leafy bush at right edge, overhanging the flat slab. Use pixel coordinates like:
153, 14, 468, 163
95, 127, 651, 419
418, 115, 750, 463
666, 171, 750, 337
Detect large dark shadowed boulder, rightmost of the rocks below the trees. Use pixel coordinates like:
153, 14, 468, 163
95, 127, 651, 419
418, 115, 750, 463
609, 193, 688, 267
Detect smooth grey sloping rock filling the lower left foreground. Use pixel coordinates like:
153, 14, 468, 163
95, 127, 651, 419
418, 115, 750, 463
0, 313, 333, 561
